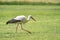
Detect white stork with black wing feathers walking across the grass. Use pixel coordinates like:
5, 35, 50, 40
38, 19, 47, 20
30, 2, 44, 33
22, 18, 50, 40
6, 15, 36, 33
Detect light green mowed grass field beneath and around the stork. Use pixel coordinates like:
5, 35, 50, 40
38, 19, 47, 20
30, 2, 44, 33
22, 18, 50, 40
0, 5, 60, 40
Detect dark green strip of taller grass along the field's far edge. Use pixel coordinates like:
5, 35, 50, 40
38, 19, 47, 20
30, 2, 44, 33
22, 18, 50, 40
0, 1, 60, 5
